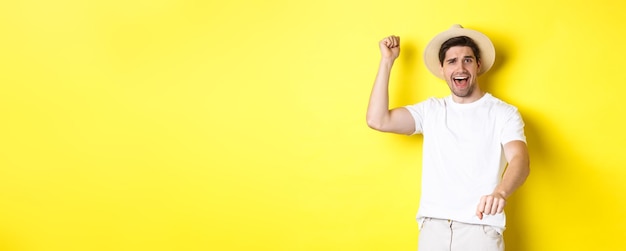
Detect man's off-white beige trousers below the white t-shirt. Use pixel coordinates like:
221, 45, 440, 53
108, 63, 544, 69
417, 218, 504, 251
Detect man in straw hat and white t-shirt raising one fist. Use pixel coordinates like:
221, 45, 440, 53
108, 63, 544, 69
367, 25, 530, 251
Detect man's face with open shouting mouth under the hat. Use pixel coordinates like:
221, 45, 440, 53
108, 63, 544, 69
441, 46, 482, 102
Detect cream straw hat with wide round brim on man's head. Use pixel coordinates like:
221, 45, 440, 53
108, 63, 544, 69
424, 25, 496, 79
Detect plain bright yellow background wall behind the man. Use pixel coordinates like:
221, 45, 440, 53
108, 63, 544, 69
0, 0, 626, 251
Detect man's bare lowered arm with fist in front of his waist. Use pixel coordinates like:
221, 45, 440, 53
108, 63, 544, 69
476, 140, 530, 219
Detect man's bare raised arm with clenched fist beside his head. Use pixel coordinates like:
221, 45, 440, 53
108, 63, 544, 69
366, 36, 415, 135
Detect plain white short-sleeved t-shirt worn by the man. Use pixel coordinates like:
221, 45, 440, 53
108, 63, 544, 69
406, 93, 526, 231
